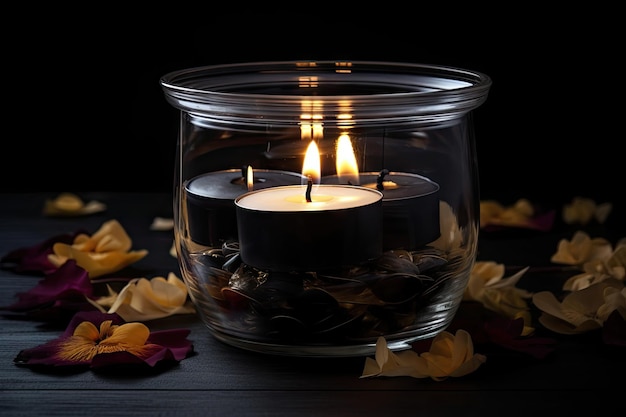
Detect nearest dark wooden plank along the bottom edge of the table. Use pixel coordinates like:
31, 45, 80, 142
0, 388, 616, 417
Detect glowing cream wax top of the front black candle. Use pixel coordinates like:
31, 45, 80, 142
236, 184, 382, 212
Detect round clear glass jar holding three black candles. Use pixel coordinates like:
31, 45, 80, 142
161, 61, 491, 357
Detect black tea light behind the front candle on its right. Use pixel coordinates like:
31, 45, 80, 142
322, 170, 440, 250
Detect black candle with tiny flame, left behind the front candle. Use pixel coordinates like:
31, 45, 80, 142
184, 167, 302, 247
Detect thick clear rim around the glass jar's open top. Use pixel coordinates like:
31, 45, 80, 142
160, 60, 492, 123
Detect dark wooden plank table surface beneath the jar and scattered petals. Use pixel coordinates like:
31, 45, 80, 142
0, 193, 626, 417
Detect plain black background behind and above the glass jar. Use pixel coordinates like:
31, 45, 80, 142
0, 7, 626, 228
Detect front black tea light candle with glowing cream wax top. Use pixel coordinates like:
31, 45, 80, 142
235, 184, 383, 271
